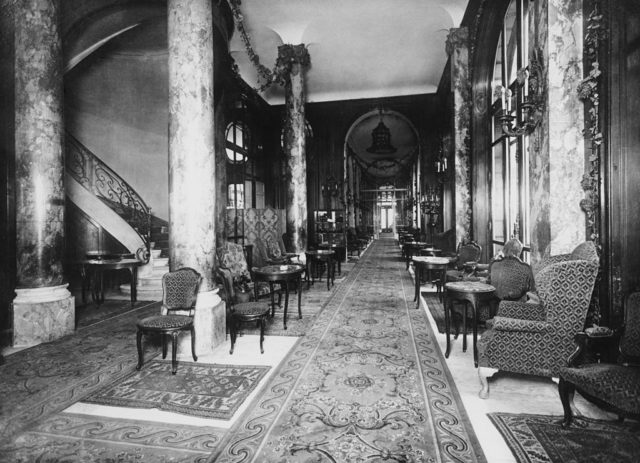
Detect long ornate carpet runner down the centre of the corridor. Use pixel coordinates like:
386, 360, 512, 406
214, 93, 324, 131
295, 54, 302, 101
210, 240, 485, 462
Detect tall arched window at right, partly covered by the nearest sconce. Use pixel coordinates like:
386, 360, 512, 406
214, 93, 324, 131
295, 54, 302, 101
490, 0, 531, 260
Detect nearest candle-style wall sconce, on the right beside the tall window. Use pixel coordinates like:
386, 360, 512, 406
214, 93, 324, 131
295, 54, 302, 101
499, 50, 546, 137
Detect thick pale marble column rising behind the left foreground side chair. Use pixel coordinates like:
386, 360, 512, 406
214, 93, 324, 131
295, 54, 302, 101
167, 0, 226, 355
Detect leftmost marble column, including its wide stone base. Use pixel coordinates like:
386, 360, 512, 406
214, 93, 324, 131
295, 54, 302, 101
13, 0, 75, 346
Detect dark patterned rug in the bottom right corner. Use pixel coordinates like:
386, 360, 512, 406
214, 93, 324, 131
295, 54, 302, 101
488, 413, 640, 463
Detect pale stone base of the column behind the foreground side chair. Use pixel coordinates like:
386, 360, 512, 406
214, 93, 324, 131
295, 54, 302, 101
178, 289, 227, 357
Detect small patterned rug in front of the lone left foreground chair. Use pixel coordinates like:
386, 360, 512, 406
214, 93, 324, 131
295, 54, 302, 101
82, 360, 270, 420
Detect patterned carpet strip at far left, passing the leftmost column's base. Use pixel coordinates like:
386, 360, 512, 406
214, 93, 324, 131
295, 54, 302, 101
0, 303, 160, 442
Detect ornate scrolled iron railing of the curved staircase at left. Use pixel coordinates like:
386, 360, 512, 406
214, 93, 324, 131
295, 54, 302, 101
65, 132, 151, 253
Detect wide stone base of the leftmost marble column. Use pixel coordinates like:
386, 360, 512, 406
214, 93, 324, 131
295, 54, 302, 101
11, 284, 76, 347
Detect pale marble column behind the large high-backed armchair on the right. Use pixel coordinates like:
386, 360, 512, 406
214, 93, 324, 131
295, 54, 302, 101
529, 0, 586, 263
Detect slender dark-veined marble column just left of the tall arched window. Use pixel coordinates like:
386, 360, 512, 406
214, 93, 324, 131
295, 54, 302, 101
446, 27, 472, 242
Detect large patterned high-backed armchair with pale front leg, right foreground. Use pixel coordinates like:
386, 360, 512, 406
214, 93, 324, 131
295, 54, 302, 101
478, 242, 599, 398
